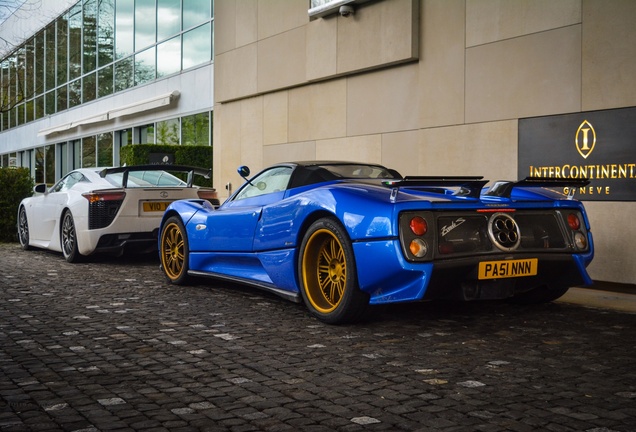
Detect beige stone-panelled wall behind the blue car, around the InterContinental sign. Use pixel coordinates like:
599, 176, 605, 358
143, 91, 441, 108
214, 0, 636, 284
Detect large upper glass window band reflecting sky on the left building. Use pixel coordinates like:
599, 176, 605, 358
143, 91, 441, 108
0, 0, 214, 131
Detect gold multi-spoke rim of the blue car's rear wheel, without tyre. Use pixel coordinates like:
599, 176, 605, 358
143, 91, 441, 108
302, 229, 347, 313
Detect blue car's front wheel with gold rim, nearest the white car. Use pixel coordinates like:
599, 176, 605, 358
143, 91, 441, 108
159, 216, 190, 285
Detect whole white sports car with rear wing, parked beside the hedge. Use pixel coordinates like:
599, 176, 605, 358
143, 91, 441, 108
17, 165, 219, 262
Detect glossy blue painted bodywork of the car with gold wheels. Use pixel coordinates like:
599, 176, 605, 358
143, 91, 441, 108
160, 164, 594, 304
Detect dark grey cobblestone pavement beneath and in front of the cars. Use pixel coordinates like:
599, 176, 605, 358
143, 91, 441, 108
0, 244, 636, 432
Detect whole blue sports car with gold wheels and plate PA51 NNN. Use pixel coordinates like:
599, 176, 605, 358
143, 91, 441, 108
159, 161, 594, 324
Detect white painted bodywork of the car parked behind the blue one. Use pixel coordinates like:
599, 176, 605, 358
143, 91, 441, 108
18, 166, 214, 261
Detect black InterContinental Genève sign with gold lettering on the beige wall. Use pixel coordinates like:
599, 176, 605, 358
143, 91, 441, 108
518, 107, 636, 201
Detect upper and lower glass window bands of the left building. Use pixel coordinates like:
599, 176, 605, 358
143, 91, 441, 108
0, 0, 214, 184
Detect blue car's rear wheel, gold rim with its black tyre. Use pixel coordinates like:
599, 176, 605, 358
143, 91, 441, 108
298, 218, 369, 324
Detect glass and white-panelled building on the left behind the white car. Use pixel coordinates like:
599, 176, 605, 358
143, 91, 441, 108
0, 0, 214, 184
